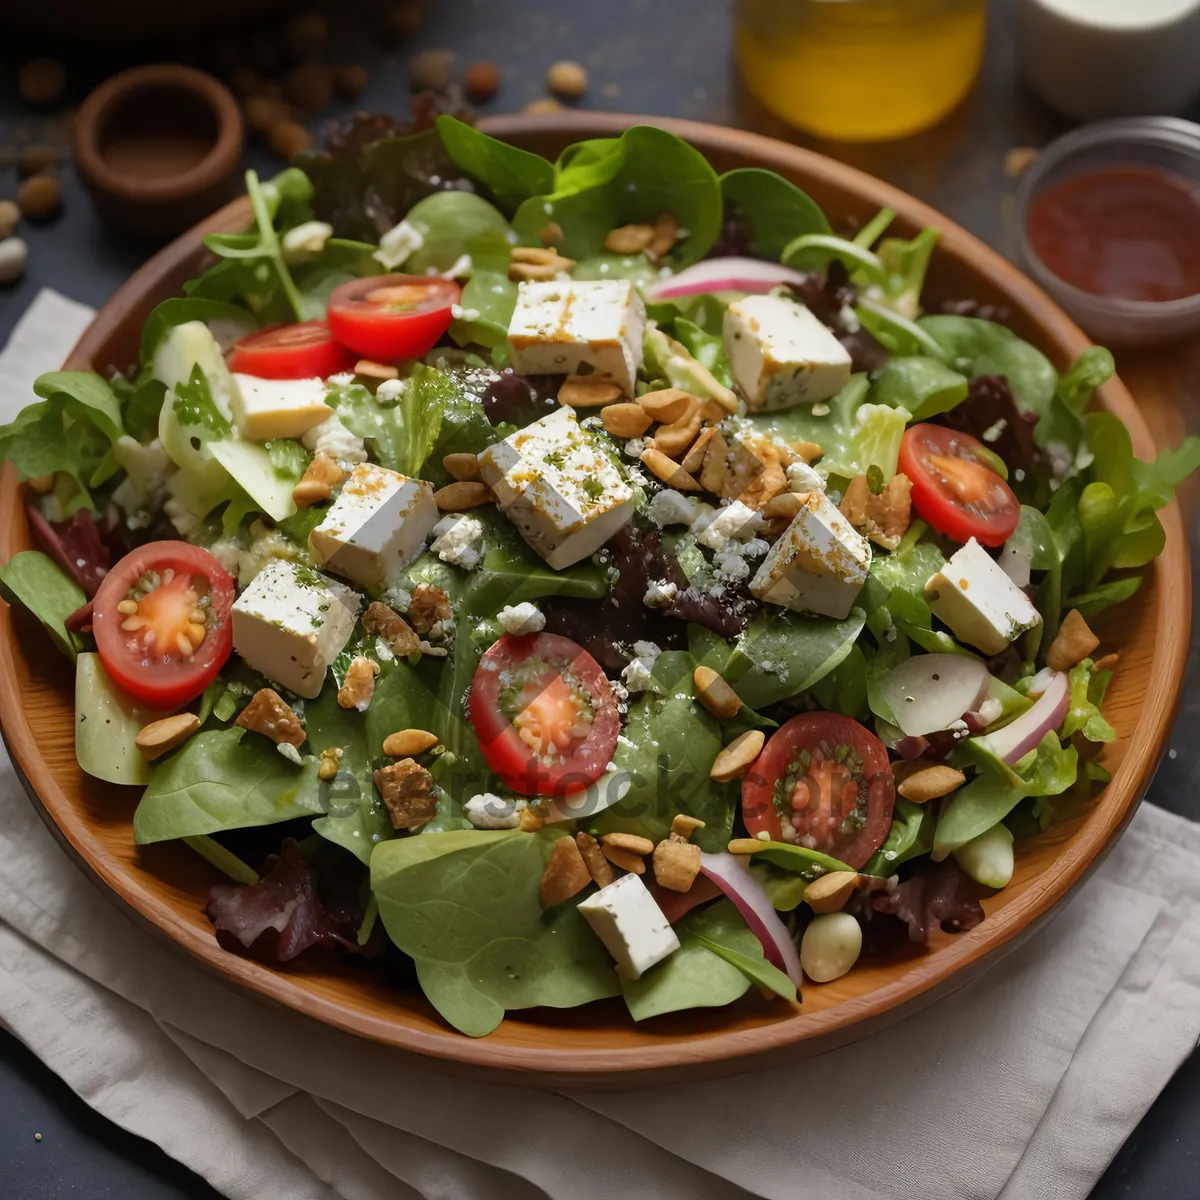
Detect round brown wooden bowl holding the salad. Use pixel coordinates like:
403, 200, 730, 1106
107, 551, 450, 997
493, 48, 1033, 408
0, 113, 1192, 1086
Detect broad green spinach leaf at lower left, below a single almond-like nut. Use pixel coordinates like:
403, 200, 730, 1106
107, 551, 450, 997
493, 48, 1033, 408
133, 727, 320, 846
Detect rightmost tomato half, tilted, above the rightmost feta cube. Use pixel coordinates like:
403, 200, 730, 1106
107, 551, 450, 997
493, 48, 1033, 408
900, 425, 1021, 546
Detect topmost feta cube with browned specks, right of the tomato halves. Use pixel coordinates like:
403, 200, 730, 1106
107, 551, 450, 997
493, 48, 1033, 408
509, 280, 646, 396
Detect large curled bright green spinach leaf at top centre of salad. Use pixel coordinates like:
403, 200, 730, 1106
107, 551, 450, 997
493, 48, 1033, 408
512, 125, 721, 266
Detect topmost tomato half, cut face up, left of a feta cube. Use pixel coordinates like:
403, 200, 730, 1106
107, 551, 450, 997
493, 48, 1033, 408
329, 275, 462, 362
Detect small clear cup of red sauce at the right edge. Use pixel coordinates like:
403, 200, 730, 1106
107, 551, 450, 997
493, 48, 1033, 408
1016, 116, 1200, 346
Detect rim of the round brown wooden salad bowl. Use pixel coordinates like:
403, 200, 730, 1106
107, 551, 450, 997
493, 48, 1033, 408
0, 113, 1190, 1086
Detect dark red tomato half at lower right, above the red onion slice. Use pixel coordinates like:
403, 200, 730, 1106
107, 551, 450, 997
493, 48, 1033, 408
742, 713, 895, 869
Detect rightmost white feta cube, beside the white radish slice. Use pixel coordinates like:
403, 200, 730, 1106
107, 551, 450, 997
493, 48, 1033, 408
925, 538, 1042, 654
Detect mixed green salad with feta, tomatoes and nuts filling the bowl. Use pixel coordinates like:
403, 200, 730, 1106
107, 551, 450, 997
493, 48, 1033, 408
0, 108, 1200, 1036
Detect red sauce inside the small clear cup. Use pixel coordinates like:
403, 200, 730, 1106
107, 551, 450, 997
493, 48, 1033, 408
1028, 166, 1200, 300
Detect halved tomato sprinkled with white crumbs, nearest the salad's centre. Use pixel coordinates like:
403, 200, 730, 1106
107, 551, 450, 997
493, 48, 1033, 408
468, 634, 620, 796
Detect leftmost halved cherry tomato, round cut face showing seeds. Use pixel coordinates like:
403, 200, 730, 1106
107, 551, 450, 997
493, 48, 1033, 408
91, 541, 235, 708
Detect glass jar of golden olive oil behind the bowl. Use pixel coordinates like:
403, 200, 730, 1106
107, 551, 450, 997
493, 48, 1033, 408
737, 0, 988, 142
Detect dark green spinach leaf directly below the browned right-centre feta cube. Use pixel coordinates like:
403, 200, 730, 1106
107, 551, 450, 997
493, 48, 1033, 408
689, 608, 865, 709
